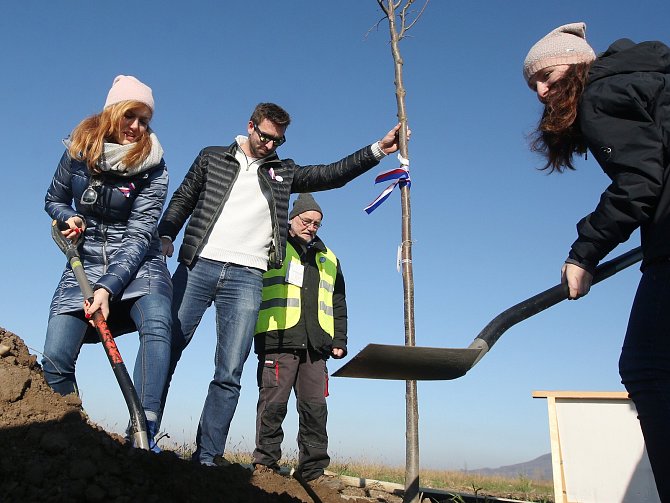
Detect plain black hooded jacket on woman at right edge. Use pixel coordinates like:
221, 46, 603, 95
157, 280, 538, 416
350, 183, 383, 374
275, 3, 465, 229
568, 39, 670, 271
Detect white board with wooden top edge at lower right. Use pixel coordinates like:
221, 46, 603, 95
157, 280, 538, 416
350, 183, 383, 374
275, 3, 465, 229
533, 391, 660, 503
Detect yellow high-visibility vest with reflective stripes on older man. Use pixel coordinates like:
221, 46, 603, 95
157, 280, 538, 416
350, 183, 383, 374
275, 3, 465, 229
256, 243, 337, 337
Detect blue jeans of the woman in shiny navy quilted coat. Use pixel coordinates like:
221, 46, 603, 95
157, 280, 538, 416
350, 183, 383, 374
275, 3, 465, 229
42, 293, 172, 420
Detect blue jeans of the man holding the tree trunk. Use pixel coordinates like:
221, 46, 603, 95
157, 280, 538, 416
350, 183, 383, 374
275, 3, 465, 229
166, 258, 263, 464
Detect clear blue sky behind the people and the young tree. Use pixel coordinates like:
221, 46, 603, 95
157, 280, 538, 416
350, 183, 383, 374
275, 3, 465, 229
0, 0, 670, 469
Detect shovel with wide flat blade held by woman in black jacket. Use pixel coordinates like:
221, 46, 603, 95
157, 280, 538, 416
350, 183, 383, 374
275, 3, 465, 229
333, 247, 642, 381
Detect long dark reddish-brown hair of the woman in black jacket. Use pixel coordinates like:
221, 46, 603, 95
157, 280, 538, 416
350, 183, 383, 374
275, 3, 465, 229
530, 63, 591, 173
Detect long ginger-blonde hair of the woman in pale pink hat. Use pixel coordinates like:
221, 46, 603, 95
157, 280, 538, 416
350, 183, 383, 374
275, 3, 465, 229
68, 101, 151, 173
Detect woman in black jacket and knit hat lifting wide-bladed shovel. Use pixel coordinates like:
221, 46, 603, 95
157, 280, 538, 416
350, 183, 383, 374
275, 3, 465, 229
523, 23, 670, 501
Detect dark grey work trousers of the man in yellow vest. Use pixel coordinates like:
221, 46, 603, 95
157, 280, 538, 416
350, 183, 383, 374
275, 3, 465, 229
253, 350, 330, 481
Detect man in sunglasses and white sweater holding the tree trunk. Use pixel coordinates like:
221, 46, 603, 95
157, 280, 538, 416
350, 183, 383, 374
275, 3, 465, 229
158, 103, 400, 465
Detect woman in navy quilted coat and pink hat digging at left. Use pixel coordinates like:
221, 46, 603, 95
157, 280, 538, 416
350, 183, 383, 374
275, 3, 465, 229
42, 75, 172, 451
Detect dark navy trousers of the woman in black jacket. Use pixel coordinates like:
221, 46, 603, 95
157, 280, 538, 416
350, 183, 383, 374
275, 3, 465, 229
619, 261, 670, 502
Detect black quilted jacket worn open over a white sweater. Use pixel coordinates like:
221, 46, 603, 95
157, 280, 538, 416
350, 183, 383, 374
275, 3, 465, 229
158, 143, 379, 268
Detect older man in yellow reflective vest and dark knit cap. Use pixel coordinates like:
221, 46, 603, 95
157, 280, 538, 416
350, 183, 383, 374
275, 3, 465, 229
253, 193, 347, 487
